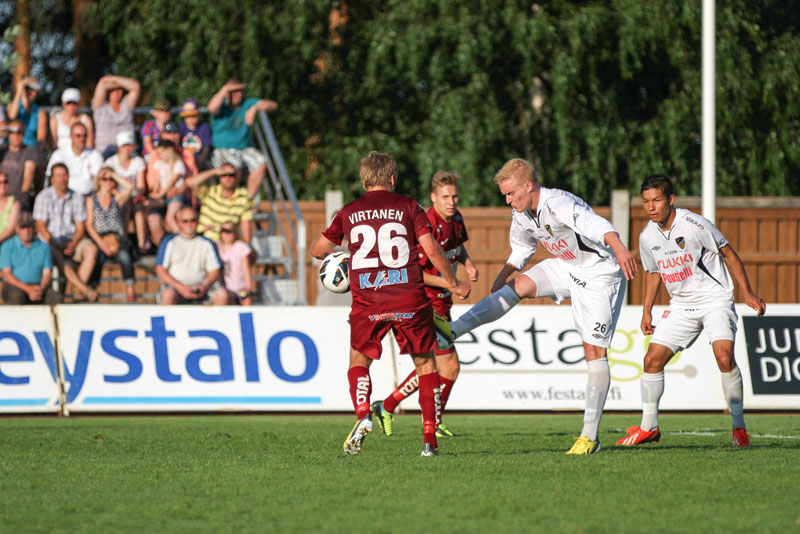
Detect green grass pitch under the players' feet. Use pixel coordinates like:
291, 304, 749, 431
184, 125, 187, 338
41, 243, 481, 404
0, 413, 800, 533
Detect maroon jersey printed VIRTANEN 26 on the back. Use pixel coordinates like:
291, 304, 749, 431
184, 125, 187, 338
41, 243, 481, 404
323, 189, 431, 312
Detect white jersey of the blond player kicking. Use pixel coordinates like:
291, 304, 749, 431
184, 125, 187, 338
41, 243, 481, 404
507, 187, 620, 280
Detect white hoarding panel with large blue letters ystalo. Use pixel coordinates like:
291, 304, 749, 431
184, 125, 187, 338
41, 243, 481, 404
57, 305, 393, 412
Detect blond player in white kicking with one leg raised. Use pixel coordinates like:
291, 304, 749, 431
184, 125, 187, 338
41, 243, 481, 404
450, 159, 636, 454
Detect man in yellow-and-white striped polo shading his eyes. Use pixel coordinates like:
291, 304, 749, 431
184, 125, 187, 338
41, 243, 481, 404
186, 163, 254, 243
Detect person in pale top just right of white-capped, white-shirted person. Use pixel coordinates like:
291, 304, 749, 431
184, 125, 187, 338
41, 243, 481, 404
147, 139, 186, 234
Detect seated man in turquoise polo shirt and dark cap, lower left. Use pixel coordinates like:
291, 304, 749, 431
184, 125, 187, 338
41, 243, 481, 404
0, 212, 62, 305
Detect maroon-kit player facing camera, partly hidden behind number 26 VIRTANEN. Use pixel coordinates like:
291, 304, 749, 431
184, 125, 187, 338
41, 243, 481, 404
372, 171, 478, 437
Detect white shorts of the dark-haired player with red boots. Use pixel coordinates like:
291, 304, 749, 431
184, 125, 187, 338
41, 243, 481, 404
650, 303, 739, 353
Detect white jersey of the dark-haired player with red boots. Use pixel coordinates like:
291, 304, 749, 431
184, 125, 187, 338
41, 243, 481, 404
639, 208, 733, 308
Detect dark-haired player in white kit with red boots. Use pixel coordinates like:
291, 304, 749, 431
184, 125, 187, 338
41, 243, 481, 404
617, 174, 766, 447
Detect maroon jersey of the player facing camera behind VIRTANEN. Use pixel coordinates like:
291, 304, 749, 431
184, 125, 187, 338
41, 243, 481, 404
419, 207, 469, 316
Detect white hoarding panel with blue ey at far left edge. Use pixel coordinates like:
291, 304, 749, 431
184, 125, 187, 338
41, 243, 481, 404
0, 306, 61, 413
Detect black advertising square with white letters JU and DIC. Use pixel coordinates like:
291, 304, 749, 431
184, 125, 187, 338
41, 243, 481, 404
742, 317, 800, 395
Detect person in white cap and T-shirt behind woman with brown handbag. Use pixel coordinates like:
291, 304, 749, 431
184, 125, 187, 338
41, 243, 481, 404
104, 132, 148, 254
